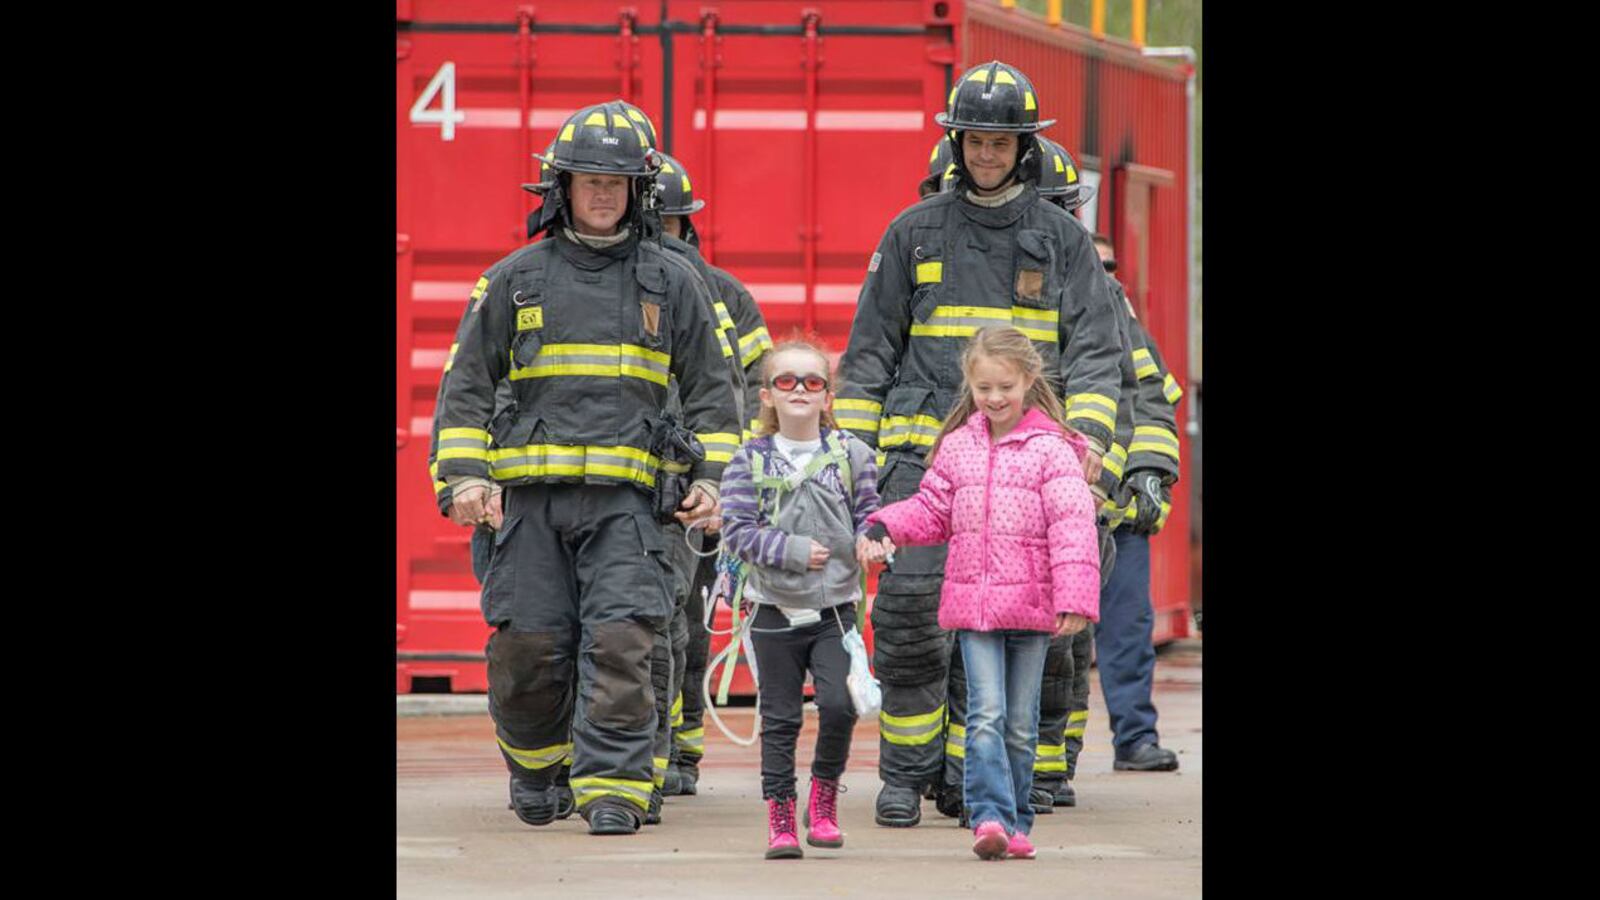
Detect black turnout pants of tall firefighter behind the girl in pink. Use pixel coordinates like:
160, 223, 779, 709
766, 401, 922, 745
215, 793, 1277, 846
872, 453, 966, 793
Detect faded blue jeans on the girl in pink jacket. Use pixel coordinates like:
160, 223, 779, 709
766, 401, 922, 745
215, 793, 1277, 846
957, 631, 1050, 834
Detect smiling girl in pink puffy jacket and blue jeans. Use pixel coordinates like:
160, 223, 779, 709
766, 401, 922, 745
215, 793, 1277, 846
867, 327, 1099, 860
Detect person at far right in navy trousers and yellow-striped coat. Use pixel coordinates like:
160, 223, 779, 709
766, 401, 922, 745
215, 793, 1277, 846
1074, 235, 1184, 772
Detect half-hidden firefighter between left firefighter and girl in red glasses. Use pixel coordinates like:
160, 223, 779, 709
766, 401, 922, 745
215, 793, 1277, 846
656, 157, 773, 796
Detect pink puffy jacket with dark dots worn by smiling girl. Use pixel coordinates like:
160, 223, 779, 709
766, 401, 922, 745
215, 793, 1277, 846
867, 408, 1099, 631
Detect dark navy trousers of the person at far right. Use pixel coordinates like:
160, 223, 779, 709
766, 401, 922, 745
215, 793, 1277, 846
1094, 528, 1157, 757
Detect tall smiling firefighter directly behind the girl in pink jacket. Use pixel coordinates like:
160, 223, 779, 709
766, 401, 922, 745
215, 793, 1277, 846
834, 61, 1122, 826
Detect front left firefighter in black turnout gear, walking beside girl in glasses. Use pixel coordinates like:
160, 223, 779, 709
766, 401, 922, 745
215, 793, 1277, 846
437, 102, 738, 834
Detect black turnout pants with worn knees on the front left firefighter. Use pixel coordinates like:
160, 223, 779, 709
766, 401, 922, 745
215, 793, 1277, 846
482, 484, 672, 815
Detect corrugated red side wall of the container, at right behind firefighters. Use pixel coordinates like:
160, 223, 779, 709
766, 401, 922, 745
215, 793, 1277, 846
962, 0, 1190, 642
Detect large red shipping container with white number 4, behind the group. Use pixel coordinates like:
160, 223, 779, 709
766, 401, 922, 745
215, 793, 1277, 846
395, 0, 1189, 693
